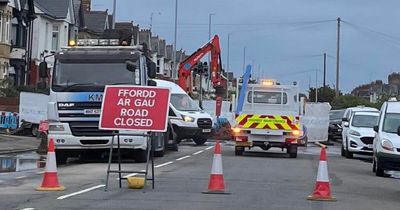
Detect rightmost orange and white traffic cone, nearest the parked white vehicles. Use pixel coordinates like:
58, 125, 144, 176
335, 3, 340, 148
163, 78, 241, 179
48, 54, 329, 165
307, 147, 336, 201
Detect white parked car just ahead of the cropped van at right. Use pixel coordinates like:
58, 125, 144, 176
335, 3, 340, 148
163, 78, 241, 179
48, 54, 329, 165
341, 111, 379, 158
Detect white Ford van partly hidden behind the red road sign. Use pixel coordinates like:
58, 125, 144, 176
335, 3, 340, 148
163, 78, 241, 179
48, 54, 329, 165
154, 79, 213, 145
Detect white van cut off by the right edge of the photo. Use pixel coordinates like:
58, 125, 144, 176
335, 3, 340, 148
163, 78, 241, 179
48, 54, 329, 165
372, 101, 400, 176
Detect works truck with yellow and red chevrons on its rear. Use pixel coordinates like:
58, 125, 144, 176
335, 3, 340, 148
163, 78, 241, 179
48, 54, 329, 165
232, 70, 302, 158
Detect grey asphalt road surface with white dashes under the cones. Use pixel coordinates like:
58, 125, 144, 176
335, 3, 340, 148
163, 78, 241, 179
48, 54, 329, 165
0, 142, 400, 210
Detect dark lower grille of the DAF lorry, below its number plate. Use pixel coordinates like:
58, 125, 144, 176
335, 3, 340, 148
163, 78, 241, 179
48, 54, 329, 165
69, 121, 112, 136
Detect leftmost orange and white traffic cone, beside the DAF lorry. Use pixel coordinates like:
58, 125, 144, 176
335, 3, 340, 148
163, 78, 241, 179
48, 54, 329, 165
36, 139, 65, 191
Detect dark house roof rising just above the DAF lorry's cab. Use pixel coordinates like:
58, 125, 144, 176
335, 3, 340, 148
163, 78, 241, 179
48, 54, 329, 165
83, 11, 108, 33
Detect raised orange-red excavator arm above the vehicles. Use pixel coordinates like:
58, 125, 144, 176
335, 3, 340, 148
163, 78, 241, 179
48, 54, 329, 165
178, 35, 227, 116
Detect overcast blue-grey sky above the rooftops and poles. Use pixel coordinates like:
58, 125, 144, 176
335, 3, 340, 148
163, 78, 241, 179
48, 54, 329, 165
92, 0, 400, 93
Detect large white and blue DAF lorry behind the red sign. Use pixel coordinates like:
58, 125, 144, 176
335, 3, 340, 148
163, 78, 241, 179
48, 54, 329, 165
35, 39, 170, 163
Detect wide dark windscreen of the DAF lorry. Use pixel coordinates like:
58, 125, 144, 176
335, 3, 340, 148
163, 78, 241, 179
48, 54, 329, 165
52, 62, 135, 92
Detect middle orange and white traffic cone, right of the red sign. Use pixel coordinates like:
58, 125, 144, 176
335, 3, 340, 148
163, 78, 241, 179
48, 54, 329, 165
203, 141, 229, 194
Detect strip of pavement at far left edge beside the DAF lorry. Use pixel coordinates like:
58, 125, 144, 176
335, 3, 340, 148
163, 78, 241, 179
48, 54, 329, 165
0, 134, 40, 155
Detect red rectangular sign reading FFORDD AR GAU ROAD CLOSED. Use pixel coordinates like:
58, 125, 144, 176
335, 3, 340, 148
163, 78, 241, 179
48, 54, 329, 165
99, 85, 170, 132
